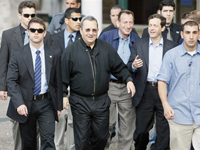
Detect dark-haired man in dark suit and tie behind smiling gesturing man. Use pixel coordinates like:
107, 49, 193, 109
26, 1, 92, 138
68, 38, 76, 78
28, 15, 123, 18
142, 0, 182, 44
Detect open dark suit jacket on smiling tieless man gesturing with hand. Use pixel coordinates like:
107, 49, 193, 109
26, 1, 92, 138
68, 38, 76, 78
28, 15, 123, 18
127, 38, 177, 107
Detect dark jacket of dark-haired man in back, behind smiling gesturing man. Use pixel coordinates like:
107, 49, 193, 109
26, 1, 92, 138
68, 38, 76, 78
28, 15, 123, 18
142, 23, 183, 44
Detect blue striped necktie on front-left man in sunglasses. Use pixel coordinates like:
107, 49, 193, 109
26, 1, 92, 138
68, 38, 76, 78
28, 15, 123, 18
34, 50, 41, 95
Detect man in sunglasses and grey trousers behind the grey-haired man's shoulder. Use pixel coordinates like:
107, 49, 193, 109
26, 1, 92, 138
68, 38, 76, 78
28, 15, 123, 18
52, 8, 81, 150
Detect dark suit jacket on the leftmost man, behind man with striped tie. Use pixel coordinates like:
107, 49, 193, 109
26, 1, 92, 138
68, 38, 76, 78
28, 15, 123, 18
0, 26, 53, 91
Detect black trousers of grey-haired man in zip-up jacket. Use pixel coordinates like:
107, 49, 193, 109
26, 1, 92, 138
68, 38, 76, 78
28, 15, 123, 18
69, 93, 110, 150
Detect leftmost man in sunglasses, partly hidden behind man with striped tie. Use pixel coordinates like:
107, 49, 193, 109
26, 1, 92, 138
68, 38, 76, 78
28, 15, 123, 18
0, 1, 52, 150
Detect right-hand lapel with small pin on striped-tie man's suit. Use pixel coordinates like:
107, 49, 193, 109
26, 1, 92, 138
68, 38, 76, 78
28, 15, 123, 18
44, 46, 53, 83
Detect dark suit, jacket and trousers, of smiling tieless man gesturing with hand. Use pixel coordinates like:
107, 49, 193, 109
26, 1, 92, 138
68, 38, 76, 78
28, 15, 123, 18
128, 38, 177, 150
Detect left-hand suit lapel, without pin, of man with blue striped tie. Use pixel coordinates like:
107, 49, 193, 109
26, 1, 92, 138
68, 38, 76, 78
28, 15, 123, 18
22, 44, 35, 81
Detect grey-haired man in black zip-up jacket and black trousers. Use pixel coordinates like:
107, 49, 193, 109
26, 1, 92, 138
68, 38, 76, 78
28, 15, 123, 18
62, 16, 135, 150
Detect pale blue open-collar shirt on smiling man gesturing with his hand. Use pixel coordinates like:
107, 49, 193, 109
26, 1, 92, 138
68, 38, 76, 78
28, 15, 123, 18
147, 38, 163, 82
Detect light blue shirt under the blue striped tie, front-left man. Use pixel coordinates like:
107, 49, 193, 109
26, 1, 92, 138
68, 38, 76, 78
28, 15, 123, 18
29, 44, 48, 94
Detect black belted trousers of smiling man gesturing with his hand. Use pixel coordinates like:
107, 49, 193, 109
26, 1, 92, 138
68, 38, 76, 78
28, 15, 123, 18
134, 85, 169, 150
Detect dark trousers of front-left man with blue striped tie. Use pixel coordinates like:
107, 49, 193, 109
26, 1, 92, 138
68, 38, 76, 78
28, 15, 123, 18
19, 98, 56, 150
